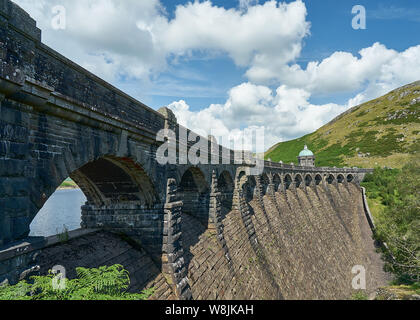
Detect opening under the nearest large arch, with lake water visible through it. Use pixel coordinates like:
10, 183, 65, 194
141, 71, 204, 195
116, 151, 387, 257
30, 157, 158, 236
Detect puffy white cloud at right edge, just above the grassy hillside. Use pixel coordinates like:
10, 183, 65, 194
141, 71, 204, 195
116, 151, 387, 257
258, 43, 420, 104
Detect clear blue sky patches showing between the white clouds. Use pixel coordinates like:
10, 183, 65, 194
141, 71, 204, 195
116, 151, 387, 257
145, 0, 420, 110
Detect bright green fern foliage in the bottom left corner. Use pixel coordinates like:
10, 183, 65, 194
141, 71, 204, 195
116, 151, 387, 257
0, 265, 153, 300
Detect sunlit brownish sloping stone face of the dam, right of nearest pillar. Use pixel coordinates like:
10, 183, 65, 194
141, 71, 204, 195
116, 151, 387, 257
178, 184, 389, 299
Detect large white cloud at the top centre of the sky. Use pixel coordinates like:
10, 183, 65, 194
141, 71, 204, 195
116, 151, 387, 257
157, 1, 309, 66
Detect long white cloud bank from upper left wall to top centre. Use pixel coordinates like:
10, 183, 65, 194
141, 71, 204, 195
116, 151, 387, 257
16, 0, 309, 84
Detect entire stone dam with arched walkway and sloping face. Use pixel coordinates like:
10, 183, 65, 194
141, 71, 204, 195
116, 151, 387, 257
0, 0, 388, 300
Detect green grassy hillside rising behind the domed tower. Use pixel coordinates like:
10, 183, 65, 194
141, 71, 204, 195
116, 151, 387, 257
265, 81, 420, 168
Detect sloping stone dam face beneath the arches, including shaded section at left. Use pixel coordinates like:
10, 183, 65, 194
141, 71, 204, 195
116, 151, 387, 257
2, 183, 389, 300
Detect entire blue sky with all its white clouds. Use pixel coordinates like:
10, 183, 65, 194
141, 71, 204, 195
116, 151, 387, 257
15, 0, 420, 149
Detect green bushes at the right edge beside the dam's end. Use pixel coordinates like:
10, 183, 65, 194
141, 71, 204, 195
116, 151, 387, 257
362, 161, 420, 284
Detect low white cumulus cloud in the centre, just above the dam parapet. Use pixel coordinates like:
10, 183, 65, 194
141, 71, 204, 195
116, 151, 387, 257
169, 83, 348, 151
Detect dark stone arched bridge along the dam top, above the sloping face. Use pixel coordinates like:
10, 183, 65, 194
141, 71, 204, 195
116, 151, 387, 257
0, 0, 382, 298
